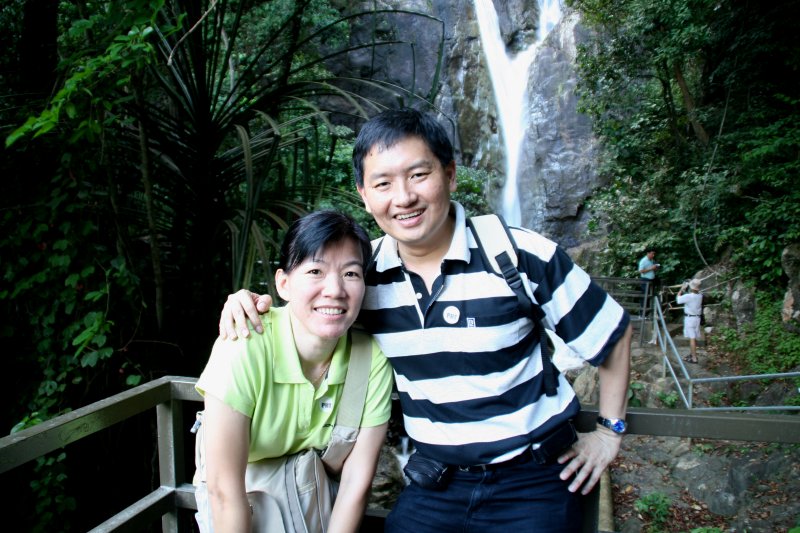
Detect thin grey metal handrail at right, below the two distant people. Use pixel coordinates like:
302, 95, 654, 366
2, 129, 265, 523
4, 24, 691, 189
642, 295, 800, 411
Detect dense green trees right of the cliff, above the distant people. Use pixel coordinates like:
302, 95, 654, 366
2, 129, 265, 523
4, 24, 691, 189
568, 0, 800, 288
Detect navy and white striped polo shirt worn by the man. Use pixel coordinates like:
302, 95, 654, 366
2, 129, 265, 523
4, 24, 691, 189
359, 202, 629, 465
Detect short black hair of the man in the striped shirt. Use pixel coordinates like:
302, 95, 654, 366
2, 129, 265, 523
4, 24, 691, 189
353, 107, 454, 187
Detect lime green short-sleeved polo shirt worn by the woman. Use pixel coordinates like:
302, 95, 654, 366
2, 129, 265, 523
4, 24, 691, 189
196, 307, 392, 462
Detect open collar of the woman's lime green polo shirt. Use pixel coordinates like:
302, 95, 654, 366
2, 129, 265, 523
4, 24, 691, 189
274, 306, 350, 385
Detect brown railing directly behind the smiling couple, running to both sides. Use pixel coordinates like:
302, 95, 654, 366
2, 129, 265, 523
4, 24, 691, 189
0, 376, 800, 532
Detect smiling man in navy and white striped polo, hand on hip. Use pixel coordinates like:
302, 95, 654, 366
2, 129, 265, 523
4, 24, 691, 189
220, 109, 630, 532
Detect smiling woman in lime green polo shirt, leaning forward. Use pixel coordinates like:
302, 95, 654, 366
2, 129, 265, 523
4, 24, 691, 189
197, 211, 392, 532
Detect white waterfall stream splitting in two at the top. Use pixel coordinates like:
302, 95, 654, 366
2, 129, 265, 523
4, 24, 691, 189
475, 0, 561, 226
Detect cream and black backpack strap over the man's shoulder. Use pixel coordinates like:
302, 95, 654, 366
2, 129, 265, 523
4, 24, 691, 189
467, 215, 558, 396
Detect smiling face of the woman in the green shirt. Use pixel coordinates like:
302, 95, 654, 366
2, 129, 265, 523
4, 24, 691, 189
275, 239, 364, 340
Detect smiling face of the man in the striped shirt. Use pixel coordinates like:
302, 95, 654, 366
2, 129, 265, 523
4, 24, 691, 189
358, 137, 456, 252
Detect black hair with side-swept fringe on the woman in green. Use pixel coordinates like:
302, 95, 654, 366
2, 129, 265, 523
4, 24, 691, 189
278, 210, 372, 272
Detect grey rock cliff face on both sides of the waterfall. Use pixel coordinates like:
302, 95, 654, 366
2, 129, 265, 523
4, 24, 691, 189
324, 0, 601, 247
